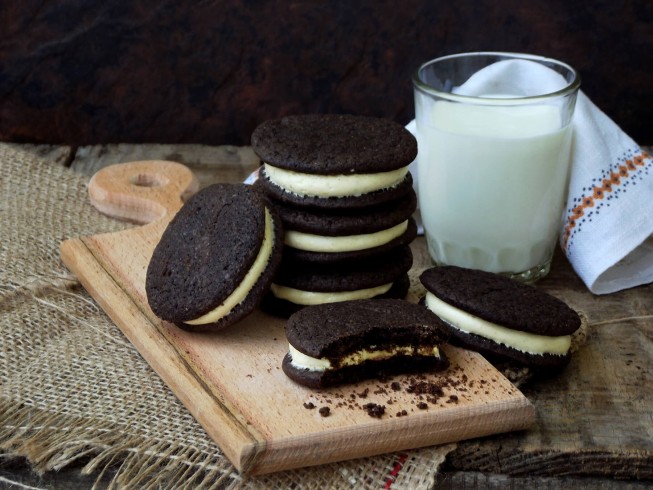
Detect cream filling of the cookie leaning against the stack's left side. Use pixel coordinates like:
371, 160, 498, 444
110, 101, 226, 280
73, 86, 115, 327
184, 208, 274, 325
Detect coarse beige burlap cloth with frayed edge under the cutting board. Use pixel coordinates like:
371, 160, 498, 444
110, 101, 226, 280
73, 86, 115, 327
0, 144, 454, 489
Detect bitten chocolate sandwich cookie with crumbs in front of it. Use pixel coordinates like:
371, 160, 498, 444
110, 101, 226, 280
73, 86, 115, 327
282, 299, 449, 388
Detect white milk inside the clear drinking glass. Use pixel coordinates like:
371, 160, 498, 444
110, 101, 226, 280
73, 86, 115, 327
417, 99, 571, 273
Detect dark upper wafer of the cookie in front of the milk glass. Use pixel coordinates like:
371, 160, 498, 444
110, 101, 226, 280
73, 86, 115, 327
420, 266, 580, 336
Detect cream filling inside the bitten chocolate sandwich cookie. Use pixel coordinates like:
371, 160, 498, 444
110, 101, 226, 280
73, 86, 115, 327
288, 344, 440, 371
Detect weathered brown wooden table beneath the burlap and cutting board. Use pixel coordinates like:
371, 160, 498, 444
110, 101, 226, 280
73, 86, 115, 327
0, 145, 653, 489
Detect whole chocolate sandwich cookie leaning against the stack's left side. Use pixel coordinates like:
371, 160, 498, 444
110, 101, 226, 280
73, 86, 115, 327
145, 184, 283, 330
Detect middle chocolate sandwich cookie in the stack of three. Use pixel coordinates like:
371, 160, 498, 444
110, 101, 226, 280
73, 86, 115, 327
274, 190, 417, 263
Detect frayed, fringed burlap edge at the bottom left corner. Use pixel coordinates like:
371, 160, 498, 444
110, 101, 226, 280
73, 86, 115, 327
0, 399, 248, 489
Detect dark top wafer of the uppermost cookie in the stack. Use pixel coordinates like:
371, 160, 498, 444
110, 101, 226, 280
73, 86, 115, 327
252, 114, 417, 175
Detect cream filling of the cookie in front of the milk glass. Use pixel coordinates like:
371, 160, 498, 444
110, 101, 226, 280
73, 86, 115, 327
426, 292, 571, 355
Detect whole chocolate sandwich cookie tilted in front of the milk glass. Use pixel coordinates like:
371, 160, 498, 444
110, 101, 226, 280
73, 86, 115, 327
420, 266, 580, 367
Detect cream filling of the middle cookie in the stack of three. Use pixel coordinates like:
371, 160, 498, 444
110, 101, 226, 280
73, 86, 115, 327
284, 220, 408, 253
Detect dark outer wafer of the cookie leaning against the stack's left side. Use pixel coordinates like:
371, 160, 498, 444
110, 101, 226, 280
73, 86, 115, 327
145, 184, 281, 323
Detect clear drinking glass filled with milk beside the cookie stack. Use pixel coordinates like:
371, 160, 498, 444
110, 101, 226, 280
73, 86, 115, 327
413, 52, 580, 282
